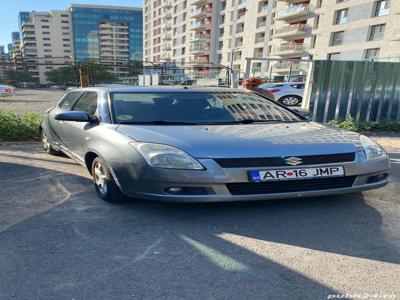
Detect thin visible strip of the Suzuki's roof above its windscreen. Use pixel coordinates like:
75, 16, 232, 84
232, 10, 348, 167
73, 86, 248, 93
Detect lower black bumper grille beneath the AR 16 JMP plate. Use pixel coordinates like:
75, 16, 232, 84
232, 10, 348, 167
226, 176, 356, 195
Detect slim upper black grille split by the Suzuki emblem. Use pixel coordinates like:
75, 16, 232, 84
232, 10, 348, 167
214, 152, 355, 168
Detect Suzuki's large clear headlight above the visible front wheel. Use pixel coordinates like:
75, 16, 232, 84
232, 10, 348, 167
129, 143, 204, 170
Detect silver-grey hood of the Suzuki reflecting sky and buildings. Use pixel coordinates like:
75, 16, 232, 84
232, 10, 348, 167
116, 122, 362, 158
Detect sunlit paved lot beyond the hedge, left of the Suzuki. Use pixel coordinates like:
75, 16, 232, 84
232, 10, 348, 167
0, 89, 65, 113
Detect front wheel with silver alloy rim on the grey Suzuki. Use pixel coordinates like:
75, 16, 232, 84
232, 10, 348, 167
92, 157, 125, 202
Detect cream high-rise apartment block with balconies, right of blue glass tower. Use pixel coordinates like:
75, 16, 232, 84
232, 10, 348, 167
144, 0, 400, 81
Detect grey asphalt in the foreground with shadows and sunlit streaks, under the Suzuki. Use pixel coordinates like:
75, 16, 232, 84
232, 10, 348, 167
0, 138, 400, 299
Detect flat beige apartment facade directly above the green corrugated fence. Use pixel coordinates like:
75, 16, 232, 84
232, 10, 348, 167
308, 0, 400, 62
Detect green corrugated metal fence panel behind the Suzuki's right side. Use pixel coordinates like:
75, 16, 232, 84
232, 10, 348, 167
308, 60, 400, 123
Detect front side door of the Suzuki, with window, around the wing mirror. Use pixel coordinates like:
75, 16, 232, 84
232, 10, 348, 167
64, 91, 98, 159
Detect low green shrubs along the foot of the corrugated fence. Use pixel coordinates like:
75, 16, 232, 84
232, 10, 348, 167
329, 117, 400, 132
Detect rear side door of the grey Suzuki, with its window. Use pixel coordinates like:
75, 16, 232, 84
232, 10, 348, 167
48, 91, 82, 147
